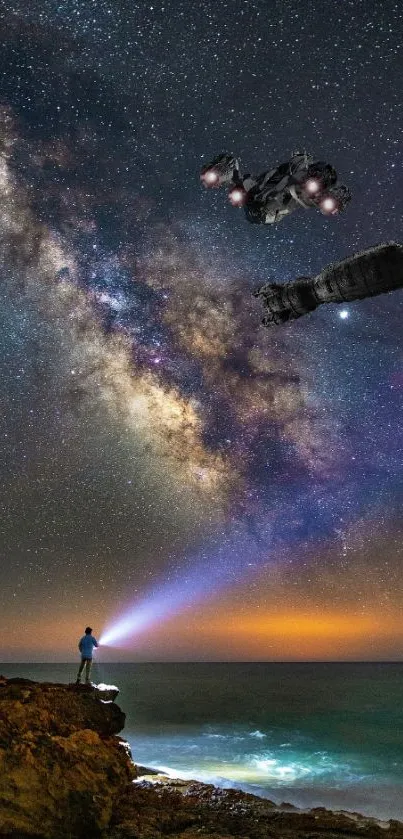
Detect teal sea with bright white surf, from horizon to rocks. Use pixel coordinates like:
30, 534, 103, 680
0, 662, 403, 820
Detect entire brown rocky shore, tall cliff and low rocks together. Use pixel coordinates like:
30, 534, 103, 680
0, 677, 403, 839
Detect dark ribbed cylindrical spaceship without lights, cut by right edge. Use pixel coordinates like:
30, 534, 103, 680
254, 242, 403, 326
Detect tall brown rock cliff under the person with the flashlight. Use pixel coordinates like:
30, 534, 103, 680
0, 679, 134, 839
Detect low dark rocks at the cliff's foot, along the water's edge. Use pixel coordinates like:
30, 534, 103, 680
108, 779, 403, 839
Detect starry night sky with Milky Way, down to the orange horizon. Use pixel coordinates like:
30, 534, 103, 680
0, 0, 403, 661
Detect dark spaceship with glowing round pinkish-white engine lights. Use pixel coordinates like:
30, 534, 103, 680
200, 152, 351, 224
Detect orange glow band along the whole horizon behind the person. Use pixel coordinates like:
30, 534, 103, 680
3, 599, 403, 663
